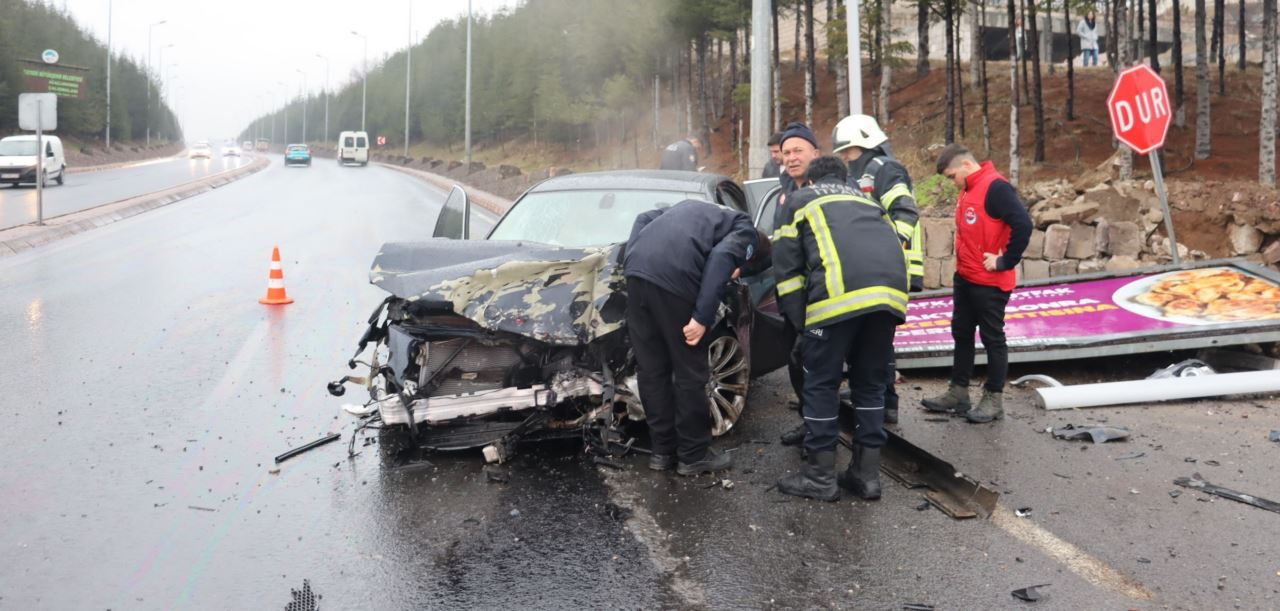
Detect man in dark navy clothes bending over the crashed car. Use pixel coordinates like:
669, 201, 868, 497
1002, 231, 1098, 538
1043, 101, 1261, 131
623, 200, 771, 475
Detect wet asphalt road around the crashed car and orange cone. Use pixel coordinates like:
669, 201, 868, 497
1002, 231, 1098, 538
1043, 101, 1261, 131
0, 163, 1280, 610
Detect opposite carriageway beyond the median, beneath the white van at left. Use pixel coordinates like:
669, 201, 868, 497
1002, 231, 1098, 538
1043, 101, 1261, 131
0, 154, 244, 229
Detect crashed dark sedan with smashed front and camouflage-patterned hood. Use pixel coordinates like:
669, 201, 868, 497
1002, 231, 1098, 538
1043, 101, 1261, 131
329, 170, 791, 461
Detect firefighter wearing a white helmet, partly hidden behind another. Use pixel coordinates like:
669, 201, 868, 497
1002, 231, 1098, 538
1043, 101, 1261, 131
831, 114, 924, 424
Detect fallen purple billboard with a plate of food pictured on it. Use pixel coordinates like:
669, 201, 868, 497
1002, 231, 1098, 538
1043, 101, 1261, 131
893, 260, 1280, 368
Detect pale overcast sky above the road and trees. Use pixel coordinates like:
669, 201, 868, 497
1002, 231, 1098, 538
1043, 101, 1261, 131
58, 0, 520, 140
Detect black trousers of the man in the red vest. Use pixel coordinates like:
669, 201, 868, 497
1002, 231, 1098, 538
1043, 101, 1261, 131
951, 273, 1010, 392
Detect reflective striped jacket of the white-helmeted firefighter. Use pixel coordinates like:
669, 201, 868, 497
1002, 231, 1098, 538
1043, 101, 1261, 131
849, 149, 924, 291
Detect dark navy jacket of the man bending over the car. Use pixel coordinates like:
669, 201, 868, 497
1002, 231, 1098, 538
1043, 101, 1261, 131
622, 200, 755, 327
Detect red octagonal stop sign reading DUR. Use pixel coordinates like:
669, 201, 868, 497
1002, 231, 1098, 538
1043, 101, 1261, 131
1107, 64, 1172, 154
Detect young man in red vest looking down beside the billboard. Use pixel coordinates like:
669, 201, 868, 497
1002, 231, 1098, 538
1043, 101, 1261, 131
923, 143, 1032, 423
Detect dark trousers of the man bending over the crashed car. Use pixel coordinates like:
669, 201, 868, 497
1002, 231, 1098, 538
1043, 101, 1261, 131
627, 277, 712, 464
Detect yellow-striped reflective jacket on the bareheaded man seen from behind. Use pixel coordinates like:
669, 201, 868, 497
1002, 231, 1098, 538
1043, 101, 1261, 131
773, 179, 908, 329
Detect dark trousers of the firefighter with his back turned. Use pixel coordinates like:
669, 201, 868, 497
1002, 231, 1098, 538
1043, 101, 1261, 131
800, 313, 897, 452
